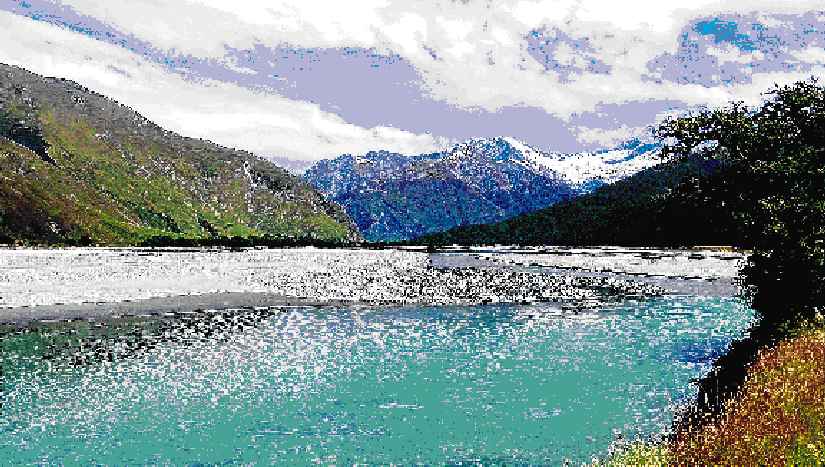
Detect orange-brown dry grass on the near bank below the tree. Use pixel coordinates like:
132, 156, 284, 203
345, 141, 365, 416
668, 330, 825, 465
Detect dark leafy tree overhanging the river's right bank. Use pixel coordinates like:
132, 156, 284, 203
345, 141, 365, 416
660, 80, 825, 321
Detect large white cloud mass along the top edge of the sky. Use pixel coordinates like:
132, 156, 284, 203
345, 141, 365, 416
33, 0, 821, 122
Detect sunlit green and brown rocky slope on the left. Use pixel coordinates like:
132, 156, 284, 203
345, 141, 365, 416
0, 65, 357, 244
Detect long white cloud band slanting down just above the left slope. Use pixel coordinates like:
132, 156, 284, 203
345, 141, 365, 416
0, 12, 445, 160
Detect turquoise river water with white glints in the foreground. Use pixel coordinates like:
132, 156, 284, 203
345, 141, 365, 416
0, 297, 753, 465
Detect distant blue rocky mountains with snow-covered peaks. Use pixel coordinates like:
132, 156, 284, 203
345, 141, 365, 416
304, 138, 660, 242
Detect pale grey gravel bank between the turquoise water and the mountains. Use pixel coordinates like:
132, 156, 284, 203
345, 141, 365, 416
0, 248, 665, 324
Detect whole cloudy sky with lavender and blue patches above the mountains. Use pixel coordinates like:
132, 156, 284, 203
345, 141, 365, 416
0, 0, 825, 161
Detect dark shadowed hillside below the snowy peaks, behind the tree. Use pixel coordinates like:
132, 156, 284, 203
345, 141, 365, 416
412, 158, 747, 246
